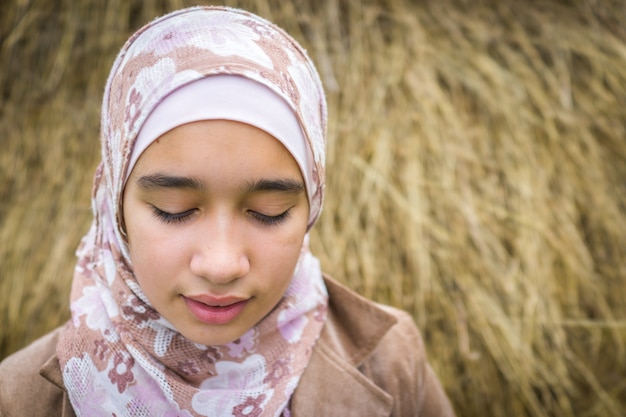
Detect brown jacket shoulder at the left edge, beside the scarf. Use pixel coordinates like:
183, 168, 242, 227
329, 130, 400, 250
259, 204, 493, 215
0, 328, 70, 417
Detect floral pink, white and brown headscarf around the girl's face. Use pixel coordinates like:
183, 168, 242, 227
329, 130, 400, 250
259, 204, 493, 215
57, 7, 327, 416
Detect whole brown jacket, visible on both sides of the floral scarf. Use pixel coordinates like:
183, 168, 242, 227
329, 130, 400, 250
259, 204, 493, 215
0, 279, 454, 417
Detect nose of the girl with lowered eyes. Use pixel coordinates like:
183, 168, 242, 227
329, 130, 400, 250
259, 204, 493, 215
190, 214, 250, 286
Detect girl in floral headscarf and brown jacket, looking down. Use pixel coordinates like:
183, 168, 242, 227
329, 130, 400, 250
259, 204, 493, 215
0, 7, 453, 416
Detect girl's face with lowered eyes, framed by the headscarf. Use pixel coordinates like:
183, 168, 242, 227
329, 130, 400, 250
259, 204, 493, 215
123, 120, 309, 345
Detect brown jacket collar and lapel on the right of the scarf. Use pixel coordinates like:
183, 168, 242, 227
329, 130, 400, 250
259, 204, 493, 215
291, 277, 397, 417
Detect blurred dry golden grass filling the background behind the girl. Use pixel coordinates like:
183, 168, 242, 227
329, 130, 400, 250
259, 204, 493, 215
0, 0, 626, 416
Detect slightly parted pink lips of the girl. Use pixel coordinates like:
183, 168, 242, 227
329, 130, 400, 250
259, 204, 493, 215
183, 295, 249, 324
